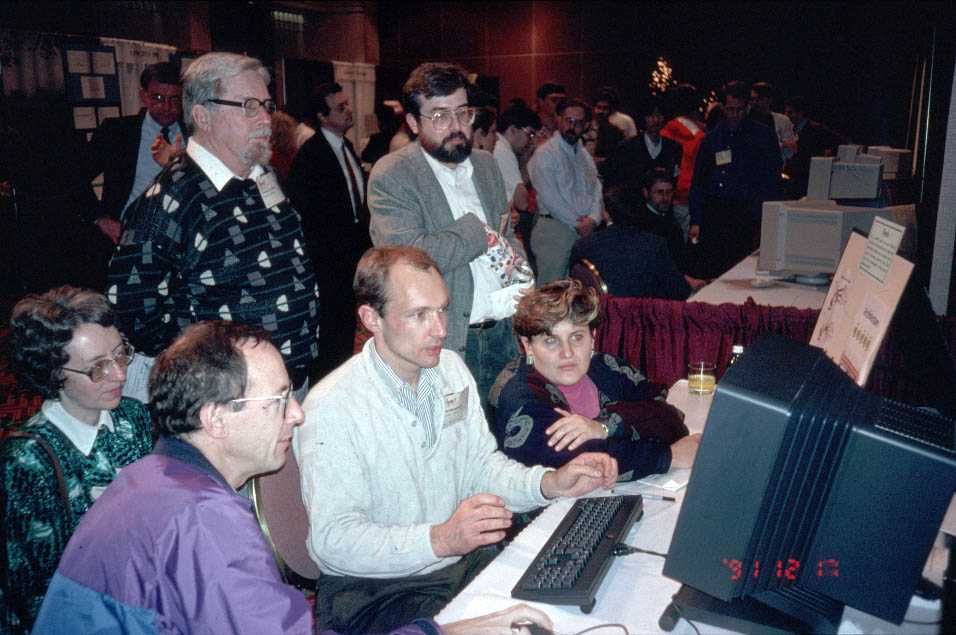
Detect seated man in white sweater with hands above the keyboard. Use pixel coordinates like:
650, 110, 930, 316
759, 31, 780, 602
293, 247, 617, 633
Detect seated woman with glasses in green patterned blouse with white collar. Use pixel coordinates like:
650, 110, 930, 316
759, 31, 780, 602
0, 286, 153, 632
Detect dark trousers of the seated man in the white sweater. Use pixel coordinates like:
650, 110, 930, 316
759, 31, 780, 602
315, 547, 498, 635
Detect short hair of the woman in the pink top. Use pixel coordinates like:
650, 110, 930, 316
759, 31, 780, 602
512, 280, 601, 338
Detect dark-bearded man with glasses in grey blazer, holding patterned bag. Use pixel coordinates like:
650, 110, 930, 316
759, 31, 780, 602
368, 63, 533, 411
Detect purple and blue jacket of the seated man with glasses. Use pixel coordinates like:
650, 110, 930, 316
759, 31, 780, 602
33, 437, 440, 635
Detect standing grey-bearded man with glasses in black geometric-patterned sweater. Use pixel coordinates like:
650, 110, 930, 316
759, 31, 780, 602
107, 53, 319, 396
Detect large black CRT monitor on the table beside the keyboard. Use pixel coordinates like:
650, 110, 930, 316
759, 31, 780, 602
664, 336, 956, 631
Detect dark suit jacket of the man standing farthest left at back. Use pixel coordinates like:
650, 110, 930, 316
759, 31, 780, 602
81, 110, 186, 221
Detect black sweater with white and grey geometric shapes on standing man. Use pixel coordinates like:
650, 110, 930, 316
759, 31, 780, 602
107, 155, 319, 386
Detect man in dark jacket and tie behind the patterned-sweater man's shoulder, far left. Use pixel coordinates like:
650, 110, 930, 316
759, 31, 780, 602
83, 62, 186, 243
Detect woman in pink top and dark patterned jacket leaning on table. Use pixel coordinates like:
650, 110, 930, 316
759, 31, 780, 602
494, 280, 700, 480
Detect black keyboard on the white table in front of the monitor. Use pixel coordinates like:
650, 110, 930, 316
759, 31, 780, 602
511, 496, 644, 613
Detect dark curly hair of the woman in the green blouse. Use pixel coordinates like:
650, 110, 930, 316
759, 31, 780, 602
10, 286, 115, 399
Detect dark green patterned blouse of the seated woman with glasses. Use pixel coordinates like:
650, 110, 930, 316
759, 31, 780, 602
0, 399, 153, 628
